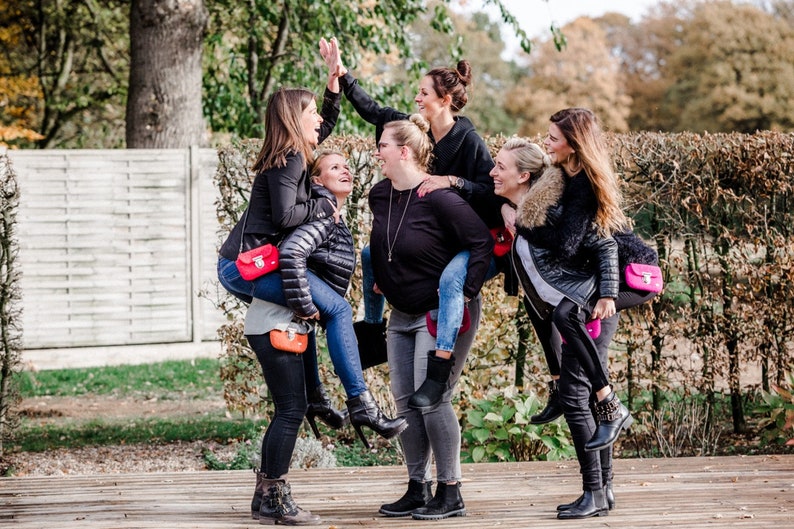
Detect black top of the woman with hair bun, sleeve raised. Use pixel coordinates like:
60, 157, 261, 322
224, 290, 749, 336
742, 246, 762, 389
339, 72, 505, 228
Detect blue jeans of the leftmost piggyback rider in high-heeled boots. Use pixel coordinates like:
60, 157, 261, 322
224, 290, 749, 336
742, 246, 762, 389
218, 257, 367, 399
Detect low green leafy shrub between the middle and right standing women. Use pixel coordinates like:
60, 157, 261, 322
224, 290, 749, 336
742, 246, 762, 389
461, 393, 574, 463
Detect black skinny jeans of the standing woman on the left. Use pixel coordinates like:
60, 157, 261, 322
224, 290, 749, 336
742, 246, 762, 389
246, 332, 316, 479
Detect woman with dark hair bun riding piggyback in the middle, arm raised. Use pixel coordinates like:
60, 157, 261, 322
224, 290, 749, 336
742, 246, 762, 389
321, 39, 504, 409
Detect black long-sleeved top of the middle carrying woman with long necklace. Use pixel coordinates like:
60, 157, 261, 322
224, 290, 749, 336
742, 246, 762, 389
369, 180, 493, 314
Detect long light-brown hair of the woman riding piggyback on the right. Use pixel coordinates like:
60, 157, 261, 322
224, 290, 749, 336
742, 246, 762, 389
549, 108, 630, 236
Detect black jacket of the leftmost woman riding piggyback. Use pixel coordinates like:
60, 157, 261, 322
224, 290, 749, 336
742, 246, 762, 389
220, 88, 342, 261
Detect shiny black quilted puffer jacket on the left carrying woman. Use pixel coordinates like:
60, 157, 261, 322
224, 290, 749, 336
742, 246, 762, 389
279, 186, 356, 317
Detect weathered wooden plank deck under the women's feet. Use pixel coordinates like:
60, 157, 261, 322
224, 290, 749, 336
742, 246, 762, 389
0, 455, 794, 529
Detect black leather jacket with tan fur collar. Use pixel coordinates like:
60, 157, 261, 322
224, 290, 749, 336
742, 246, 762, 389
511, 167, 619, 316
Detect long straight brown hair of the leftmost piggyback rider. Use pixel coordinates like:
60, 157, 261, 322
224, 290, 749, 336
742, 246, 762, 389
254, 88, 315, 172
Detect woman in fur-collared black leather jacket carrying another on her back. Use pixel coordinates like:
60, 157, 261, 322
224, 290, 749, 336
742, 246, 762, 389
491, 122, 636, 518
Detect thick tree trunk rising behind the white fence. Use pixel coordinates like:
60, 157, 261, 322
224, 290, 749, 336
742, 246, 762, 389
126, 0, 208, 149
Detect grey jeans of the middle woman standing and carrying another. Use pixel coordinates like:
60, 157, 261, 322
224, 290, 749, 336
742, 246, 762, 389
387, 296, 482, 483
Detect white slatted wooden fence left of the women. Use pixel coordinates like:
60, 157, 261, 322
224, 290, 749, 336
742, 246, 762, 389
8, 148, 222, 349
